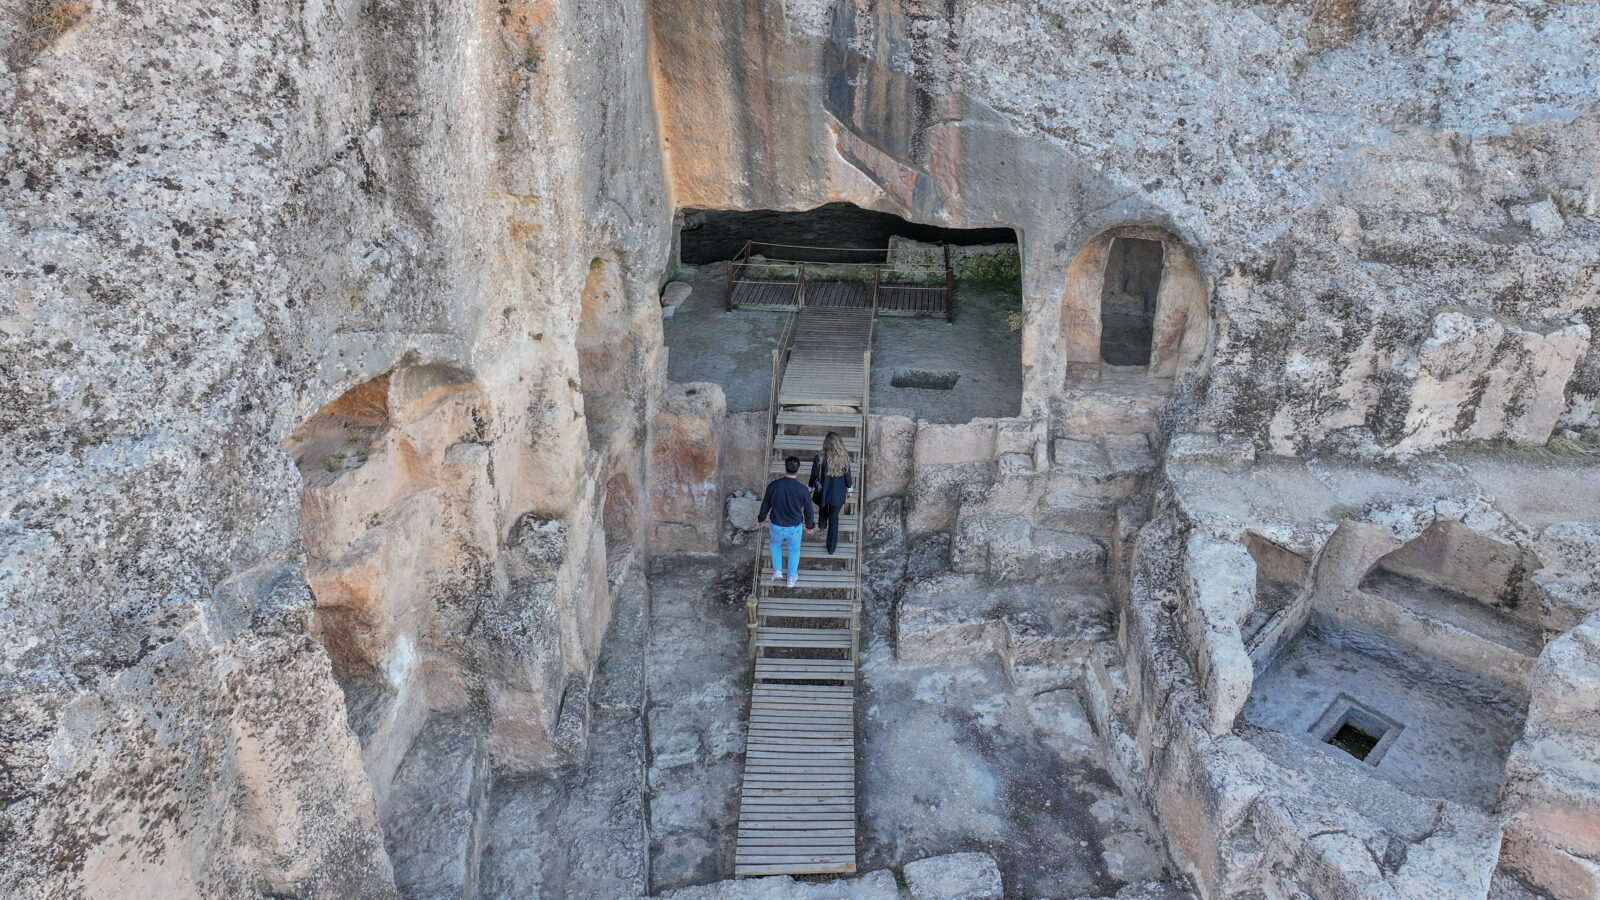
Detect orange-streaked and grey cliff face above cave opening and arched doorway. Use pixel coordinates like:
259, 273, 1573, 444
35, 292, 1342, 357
653, 0, 1600, 453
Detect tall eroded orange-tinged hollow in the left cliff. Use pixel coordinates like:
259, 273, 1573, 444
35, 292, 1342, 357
285, 365, 498, 810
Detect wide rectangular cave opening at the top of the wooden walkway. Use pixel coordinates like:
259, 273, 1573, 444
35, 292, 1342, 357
664, 203, 1022, 423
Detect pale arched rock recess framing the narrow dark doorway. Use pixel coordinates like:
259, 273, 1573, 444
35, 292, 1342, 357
1061, 226, 1210, 378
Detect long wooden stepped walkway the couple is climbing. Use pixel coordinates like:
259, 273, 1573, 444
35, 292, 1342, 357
734, 306, 872, 878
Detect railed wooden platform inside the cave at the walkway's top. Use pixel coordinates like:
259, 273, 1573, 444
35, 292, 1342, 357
728, 240, 955, 322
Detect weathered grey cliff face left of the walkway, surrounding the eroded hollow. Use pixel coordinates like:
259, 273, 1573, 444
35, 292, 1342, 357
0, 0, 670, 897
